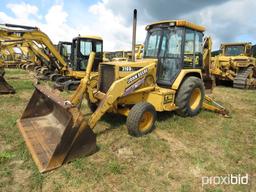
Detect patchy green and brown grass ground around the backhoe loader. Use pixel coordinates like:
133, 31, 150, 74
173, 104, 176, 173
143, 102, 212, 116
0, 69, 256, 192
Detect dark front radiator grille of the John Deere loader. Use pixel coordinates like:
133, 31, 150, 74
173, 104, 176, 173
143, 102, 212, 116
99, 64, 115, 93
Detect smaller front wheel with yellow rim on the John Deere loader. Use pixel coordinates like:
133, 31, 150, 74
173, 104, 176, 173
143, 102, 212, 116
126, 102, 156, 137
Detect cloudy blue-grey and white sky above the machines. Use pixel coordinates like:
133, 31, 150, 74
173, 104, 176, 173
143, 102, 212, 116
0, 0, 256, 51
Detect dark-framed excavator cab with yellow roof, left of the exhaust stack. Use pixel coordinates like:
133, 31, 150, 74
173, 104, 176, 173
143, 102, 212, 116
71, 36, 103, 71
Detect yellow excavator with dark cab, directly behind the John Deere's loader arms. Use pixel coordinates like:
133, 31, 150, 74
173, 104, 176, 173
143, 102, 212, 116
0, 24, 103, 89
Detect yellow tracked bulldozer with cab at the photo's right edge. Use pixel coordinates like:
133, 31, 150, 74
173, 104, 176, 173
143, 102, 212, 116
211, 43, 256, 89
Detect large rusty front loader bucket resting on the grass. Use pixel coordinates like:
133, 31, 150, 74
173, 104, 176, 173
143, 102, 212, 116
17, 85, 96, 172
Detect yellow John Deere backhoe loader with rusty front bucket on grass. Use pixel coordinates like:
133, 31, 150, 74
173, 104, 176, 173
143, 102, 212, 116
17, 10, 227, 172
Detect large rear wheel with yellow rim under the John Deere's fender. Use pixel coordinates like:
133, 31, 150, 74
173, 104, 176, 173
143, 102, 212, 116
175, 77, 205, 117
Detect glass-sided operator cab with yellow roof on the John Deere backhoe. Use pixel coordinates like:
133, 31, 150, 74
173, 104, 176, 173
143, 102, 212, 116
144, 20, 205, 87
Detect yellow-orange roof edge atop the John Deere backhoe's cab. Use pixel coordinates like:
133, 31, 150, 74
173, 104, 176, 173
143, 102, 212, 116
146, 20, 205, 32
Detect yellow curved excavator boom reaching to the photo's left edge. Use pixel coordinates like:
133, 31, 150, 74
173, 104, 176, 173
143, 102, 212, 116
0, 25, 68, 73
